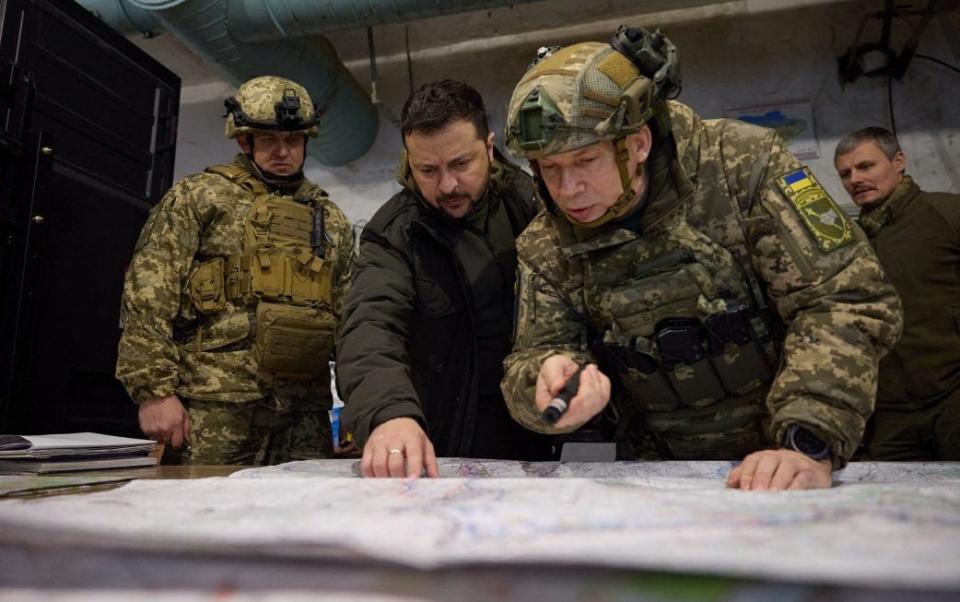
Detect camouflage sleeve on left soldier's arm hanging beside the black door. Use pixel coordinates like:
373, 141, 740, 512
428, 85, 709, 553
116, 181, 201, 403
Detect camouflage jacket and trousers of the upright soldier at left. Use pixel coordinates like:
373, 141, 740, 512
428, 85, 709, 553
117, 78, 353, 464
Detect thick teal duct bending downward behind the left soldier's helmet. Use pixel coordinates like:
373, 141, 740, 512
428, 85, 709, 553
85, 0, 379, 166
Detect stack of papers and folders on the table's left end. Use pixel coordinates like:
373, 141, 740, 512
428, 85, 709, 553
0, 433, 157, 473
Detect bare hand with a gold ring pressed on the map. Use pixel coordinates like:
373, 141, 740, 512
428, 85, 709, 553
360, 418, 440, 479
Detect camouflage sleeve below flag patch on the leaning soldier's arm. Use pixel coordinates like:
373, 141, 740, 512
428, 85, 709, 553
748, 136, 903, 465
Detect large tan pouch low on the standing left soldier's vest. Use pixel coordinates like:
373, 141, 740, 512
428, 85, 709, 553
253, 302, 336, 379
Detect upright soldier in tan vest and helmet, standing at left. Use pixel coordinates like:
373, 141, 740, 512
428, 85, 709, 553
117, 76, 353, 464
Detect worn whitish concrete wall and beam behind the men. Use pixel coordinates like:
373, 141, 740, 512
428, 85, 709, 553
159, 0, 960, 221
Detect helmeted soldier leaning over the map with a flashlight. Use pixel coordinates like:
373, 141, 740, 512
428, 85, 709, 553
502, 28, 901, 490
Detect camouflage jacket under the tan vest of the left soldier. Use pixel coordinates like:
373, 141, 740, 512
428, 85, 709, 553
117, 155, 353, 403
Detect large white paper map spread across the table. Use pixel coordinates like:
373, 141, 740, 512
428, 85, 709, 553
0, 459, 960, 589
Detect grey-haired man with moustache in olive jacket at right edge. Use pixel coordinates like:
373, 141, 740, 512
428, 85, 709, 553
834, 127, 960, 460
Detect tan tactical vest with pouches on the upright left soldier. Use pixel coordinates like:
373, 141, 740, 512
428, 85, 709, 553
188, 164, 336, 379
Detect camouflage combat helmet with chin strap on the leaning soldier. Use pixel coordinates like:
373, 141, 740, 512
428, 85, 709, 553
506, 26, 680, 226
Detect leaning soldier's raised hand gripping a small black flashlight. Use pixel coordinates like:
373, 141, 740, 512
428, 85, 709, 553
534, 355, 610, 431
